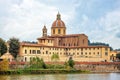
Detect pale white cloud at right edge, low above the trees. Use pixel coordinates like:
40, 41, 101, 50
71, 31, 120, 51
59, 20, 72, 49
94, 10, 120, 48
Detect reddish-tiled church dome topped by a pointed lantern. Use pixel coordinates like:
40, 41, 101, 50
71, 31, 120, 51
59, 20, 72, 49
52, 13, 65, 28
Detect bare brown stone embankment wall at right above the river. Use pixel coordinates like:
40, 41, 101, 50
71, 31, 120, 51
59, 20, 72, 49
75, 62, 120, 72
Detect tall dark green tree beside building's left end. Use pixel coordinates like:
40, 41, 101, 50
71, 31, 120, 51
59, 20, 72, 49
9, 37, 20, 58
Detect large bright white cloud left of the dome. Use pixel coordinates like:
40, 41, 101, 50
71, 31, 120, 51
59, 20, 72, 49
1, 0, 76, 40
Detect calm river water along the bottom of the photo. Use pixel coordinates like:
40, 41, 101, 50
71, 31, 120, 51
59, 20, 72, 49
0, 73, 120, 80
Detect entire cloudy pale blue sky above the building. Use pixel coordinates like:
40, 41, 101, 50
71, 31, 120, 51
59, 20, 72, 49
0, 0, 120, 49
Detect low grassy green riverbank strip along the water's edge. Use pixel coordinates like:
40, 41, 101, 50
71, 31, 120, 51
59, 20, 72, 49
0, 69, 90, 75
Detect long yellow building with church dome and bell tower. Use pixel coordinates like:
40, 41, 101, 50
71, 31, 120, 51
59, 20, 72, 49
19, 13, 110, 62
